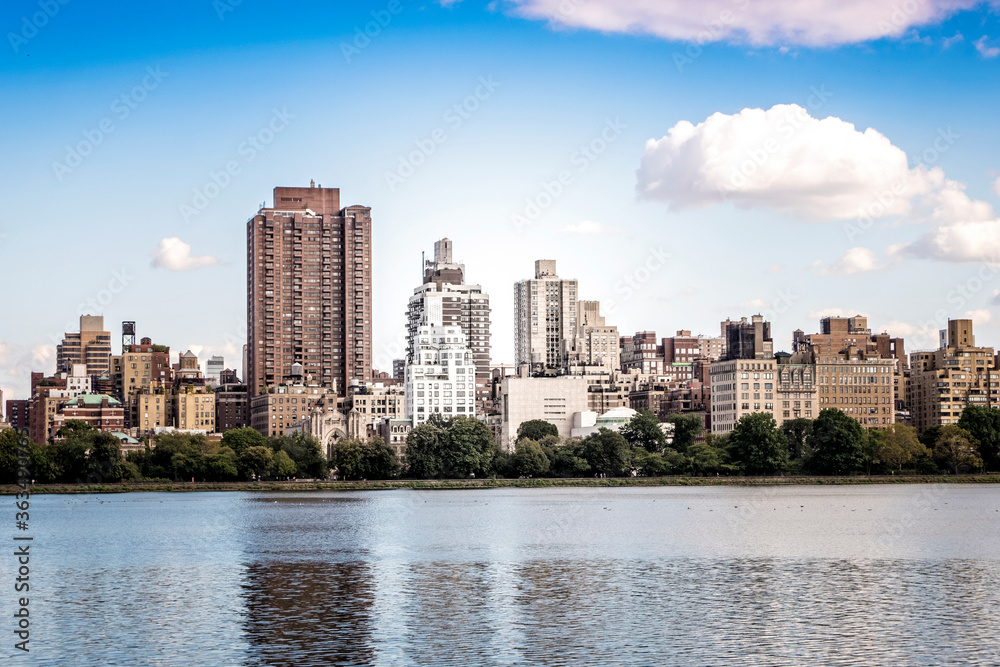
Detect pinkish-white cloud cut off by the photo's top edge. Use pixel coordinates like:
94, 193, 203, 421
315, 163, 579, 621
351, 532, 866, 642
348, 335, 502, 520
488, 0, 983, 47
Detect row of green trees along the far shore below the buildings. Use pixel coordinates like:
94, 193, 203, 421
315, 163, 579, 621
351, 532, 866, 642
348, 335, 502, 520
0, 406, 1000, 483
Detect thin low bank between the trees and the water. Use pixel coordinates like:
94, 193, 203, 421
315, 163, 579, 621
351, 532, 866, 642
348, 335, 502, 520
7, 474, 1000, 495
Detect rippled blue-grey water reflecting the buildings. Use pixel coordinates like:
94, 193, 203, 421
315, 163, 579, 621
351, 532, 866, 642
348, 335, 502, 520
0, 487, 1000, 667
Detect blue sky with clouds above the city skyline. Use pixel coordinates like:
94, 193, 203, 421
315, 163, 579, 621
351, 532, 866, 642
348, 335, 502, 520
0, 0, 1000, 398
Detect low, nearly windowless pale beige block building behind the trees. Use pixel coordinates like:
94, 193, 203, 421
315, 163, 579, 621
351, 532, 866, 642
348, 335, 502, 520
497, 374, 589, 451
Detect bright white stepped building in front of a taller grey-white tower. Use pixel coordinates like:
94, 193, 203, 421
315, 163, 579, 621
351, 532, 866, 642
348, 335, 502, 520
406, 325, 477, 426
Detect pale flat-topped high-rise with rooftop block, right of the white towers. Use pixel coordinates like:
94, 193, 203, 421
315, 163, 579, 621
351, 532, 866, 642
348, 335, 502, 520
514, 259, 577, 369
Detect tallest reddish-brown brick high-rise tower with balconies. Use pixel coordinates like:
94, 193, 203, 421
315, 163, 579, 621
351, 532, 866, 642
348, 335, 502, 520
245, 185, 372, 400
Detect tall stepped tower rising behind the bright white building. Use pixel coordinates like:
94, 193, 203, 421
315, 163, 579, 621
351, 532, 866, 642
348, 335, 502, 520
406, 238, 492, 414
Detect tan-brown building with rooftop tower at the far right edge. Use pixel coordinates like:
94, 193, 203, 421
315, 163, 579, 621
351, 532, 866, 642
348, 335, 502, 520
907, 320, 1000, 433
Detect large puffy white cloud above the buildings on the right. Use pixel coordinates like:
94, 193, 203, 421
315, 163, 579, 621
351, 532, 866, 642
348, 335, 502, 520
637, 104, 994, 224
